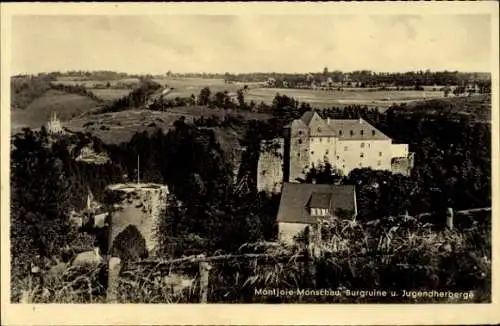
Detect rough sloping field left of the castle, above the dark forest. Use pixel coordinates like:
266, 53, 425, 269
63, 107, 269, 144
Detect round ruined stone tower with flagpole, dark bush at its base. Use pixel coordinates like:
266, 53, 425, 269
108, 184, 168, 256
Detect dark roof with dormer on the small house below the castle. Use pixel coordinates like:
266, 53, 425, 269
277, 183, 356, 224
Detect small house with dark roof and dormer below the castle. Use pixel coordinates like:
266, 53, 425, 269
277, 183, 357, 244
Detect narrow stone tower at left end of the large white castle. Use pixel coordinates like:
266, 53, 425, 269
283, 119, 309, 182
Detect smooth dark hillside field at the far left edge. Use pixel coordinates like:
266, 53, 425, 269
11, 90, 99, 131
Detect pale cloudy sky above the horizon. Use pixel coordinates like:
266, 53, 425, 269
11, 14, 491, 74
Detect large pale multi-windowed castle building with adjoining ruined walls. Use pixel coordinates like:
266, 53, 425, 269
257, 111, 413, 191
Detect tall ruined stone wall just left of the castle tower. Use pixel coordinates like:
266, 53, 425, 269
257, 138, 284, 193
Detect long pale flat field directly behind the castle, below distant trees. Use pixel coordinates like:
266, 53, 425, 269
245, 88, 450, 108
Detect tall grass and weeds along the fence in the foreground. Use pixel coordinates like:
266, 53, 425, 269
18, 216, 491, 303
